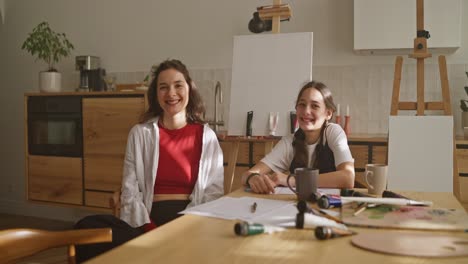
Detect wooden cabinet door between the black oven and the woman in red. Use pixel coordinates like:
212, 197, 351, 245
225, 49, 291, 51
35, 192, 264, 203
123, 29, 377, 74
83, 97, 145, 191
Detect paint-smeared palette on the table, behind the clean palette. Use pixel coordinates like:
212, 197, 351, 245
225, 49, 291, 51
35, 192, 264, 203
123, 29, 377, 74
341, 202, 468, 231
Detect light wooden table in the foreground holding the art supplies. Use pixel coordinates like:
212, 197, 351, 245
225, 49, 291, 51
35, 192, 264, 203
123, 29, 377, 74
89, 189, 468, 264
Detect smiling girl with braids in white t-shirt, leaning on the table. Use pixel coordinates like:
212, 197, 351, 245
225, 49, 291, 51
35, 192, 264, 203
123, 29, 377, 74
242, 81, 354, 194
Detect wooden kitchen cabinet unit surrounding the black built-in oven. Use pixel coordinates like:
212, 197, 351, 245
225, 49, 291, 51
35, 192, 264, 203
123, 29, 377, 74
25, 91, 146, 208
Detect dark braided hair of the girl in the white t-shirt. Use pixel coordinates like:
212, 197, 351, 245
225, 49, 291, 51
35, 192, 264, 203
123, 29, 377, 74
289, 81, 336, 173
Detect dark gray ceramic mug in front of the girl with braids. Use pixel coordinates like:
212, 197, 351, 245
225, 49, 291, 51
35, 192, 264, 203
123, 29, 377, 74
286, 168, 319, 202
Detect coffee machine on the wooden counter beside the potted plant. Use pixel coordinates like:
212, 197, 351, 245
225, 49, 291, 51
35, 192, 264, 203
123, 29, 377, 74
75, 56, 107, 91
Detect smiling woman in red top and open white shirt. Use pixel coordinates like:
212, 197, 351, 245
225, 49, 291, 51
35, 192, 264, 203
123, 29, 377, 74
75, 60, 224, 261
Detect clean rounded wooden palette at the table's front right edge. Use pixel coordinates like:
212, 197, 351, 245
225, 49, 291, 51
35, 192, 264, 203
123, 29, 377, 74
351, 232, 468, 257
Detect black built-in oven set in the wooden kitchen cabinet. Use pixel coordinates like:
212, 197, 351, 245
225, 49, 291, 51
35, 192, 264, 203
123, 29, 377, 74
28, 96, 83, 157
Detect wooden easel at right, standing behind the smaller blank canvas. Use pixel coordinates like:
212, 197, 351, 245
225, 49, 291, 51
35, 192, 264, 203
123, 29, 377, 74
390, 0, 460, 197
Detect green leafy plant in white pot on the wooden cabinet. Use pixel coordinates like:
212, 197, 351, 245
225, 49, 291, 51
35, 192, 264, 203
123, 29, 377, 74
21, 22, 74, 92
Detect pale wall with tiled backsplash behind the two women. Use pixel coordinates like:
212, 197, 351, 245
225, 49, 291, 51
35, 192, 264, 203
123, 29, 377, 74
0, 0, 468, 222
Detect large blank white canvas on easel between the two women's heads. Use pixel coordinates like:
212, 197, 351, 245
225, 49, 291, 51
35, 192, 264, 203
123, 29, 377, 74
228, 32, 313, 136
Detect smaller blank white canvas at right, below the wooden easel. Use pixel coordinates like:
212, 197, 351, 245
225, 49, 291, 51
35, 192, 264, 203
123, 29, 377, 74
388, 116, 453, 192
